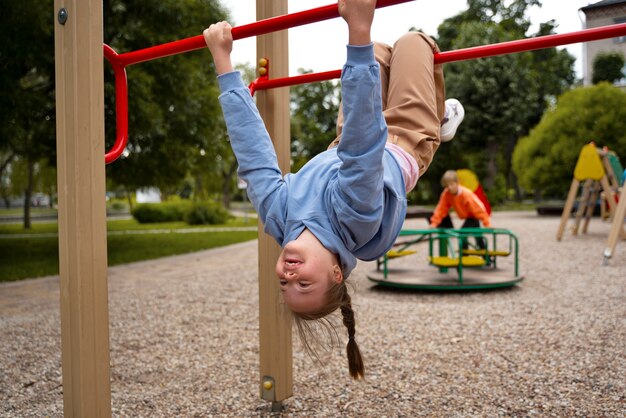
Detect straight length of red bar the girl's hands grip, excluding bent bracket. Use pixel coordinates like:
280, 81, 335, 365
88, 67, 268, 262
113, 0, 414, 66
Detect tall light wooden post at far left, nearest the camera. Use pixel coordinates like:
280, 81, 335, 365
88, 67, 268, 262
54, 0, 111, 417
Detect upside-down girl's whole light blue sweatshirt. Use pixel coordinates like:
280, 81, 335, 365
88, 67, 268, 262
218, 44, 406, 277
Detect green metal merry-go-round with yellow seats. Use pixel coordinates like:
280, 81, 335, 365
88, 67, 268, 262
367, 228, 524, 290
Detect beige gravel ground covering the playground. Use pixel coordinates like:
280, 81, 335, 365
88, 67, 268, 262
0, 212, 626, 417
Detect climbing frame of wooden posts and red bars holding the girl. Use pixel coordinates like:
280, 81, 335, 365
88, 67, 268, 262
55, 0, 626, 417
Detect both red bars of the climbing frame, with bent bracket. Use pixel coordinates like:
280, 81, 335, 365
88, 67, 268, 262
103, 0, 626, 164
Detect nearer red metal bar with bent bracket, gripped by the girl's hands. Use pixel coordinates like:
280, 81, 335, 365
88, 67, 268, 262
104, 0, 414, 164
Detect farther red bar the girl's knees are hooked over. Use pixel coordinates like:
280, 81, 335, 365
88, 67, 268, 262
250, 23, 626, 94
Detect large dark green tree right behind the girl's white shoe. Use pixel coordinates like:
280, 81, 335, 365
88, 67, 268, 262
422, 0, 574, 201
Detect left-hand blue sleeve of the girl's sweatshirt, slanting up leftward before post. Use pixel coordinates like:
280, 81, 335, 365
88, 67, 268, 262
218, 71, 284, 222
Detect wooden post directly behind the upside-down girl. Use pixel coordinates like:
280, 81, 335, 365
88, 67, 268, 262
256, 0, 293, 410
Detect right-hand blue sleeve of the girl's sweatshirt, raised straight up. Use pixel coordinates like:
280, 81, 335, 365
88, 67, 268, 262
335, 44, 387, 234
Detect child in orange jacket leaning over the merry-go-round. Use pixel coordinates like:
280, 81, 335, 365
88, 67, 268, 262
430, 170, 491, 249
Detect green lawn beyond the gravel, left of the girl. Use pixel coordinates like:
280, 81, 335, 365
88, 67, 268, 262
0, 219, 257, 282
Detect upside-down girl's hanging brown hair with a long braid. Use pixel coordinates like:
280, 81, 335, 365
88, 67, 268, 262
293, 280, 365, 380
